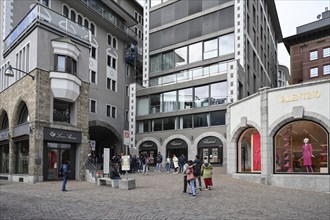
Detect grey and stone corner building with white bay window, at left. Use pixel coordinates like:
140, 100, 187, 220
0, 0, 143, 182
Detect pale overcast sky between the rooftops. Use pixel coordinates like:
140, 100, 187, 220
138, 0, 330, 69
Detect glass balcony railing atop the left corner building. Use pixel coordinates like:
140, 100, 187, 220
4, 4, 91, 52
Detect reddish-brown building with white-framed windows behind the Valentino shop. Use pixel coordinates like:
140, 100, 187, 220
283, 8, 330, 84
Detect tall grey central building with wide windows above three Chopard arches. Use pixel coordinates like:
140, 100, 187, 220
130, 0, 282, 164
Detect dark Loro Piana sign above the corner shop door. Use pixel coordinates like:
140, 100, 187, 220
44, 128, 81, 143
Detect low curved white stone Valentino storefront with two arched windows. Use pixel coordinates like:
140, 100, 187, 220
227, 79, 330, 192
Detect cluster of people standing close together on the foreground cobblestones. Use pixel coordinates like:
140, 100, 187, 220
183, 155, 213, 197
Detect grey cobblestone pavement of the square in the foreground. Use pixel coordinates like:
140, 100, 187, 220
0, 168, 330, 220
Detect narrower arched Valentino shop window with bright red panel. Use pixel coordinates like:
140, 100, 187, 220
237, 128, 261, 173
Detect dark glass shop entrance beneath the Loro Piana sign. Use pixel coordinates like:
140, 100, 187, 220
46, 143, 74, 180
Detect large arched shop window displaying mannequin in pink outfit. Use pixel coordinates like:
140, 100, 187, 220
274, 120, 329, 174
